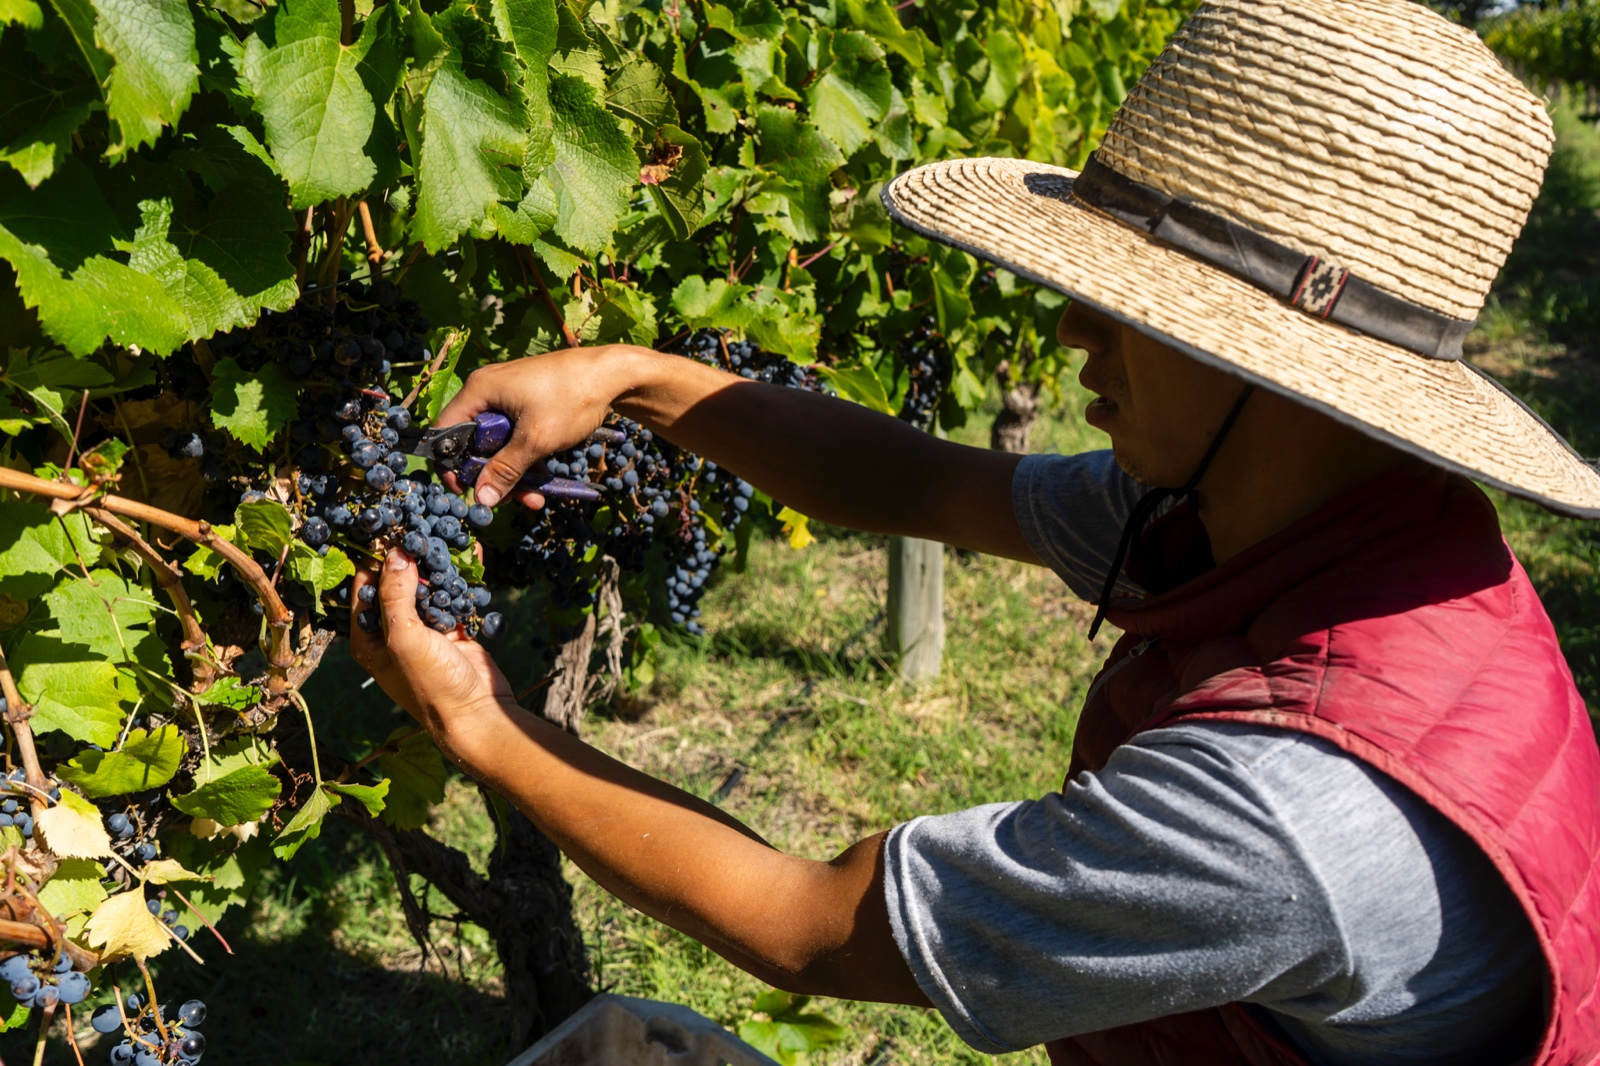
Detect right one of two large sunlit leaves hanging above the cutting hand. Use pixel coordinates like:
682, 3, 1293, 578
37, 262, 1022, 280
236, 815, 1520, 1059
544, 74, 638, 256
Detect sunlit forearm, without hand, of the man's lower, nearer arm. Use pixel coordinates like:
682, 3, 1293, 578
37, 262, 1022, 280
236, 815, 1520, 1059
442, 703, 926, 1005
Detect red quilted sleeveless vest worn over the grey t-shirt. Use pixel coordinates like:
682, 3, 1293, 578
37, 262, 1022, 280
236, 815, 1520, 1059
1048, 467, 1600, 1066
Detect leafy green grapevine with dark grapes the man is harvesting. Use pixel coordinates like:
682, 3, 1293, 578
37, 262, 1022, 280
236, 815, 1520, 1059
0, 0, 1192, 1049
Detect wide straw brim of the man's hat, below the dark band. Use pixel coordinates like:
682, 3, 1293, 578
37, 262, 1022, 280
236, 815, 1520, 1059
883, 158, 1600, 519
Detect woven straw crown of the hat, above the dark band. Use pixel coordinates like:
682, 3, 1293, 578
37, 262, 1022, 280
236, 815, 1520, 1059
1096, 0, 1554, 319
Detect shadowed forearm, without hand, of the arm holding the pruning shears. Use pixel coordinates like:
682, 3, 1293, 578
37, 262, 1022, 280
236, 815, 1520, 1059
606, 347, 1035, 562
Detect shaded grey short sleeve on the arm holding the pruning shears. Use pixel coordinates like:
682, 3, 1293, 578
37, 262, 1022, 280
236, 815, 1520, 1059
1011, 451, 1147, 602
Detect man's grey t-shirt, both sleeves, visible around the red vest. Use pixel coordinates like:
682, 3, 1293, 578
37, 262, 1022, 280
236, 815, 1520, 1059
885, 453, 1546, 1066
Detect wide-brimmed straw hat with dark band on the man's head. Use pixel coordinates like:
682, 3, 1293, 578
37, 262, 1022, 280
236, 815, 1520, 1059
883, 0, 1600, 519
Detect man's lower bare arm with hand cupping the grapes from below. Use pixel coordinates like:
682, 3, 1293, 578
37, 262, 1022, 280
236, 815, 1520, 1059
350, 552, 928, 1005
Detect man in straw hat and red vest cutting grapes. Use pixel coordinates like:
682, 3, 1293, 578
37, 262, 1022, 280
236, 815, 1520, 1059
352, 0, 1600, 1066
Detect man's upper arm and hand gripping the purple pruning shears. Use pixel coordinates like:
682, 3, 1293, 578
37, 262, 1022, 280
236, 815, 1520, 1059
438, 344, 1038, 562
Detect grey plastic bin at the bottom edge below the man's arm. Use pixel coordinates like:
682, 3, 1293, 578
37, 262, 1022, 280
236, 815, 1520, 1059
507, 996, 778, 1066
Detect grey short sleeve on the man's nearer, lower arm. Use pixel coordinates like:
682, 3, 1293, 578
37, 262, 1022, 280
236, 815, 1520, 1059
885, 723, 1347, 1053
